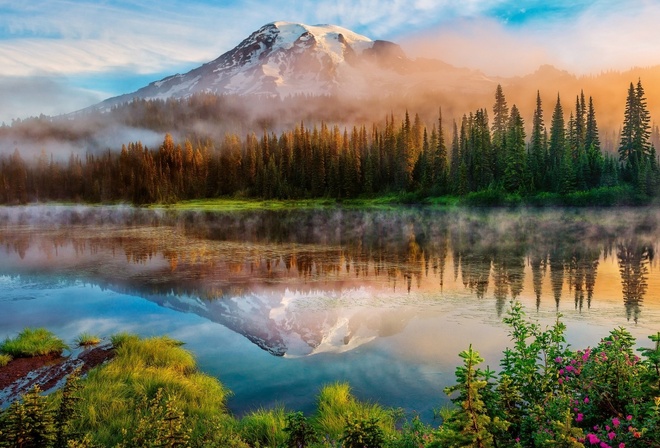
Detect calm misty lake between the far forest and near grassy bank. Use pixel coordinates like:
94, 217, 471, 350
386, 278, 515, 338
0, 206, 660, 421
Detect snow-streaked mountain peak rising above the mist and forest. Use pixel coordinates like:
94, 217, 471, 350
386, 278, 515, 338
105, 22, 416, 104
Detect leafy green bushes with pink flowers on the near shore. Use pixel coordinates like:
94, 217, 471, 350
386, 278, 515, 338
426, 302, 660, 448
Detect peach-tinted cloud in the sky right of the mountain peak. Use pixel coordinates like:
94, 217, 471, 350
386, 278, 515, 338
400, 2, 660, 76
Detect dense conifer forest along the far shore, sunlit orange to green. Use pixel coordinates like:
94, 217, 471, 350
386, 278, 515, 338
0, 81, 660, 204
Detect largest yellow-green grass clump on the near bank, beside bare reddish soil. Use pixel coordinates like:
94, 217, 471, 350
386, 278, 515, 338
77, 333, 229, 446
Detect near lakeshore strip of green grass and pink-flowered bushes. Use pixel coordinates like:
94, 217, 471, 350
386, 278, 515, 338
0, 303, 660, 448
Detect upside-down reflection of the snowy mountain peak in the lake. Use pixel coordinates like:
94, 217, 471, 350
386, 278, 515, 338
145, 287, 411, 357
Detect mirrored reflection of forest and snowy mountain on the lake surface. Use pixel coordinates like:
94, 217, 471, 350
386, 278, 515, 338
0, 207, 660, 355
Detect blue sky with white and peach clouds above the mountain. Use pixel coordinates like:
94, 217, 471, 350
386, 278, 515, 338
0, 0, 660, 123
